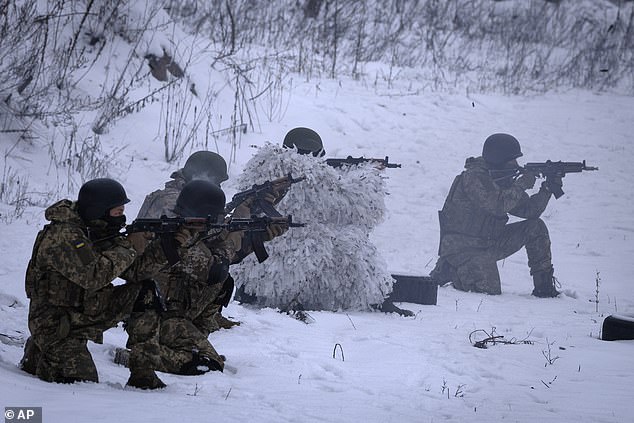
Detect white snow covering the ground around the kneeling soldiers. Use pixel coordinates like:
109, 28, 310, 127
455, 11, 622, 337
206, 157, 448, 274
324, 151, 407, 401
0, 6, 634, 423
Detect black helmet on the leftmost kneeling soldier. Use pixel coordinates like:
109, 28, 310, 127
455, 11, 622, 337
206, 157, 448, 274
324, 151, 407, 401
77, 178, 130, 222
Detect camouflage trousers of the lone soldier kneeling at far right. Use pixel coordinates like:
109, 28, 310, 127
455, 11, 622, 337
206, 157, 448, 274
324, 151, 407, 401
431, 219, 552, 295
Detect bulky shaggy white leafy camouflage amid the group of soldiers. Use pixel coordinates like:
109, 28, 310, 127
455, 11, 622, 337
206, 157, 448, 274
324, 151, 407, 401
231, 144, 394, 311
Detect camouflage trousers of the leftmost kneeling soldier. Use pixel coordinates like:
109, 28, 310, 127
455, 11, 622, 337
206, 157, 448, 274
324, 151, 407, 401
21, 283, 158, 383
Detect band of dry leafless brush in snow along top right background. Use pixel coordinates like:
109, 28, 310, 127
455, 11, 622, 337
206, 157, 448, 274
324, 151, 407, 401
170, 0, 634, 93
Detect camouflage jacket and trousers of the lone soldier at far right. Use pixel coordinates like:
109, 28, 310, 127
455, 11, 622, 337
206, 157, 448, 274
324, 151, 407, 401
432, 157, 552, 294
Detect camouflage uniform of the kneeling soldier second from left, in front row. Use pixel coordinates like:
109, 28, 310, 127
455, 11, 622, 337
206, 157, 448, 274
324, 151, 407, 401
151, 235, 232, 374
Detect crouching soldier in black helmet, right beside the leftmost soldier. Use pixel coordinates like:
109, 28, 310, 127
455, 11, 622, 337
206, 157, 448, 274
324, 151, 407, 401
150, 180, 235, 375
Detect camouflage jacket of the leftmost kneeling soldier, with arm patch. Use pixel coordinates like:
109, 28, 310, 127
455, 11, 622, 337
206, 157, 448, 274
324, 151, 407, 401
25, 200, 167, 314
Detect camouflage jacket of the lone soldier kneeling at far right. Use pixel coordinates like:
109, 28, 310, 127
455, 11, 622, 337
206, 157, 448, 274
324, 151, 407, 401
439, 157, 551, 255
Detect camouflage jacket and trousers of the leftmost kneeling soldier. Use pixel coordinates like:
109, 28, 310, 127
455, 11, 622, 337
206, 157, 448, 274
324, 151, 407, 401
22, 200, 167, 383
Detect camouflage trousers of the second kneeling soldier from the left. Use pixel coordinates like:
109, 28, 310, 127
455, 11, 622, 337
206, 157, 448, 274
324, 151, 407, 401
156, 316, 224, 374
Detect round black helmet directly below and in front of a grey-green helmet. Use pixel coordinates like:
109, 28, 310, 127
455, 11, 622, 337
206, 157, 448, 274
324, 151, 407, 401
174, 179, 225, 217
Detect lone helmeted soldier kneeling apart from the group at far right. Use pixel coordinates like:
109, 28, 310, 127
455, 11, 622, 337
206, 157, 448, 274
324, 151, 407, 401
431, 133, 562, 298
